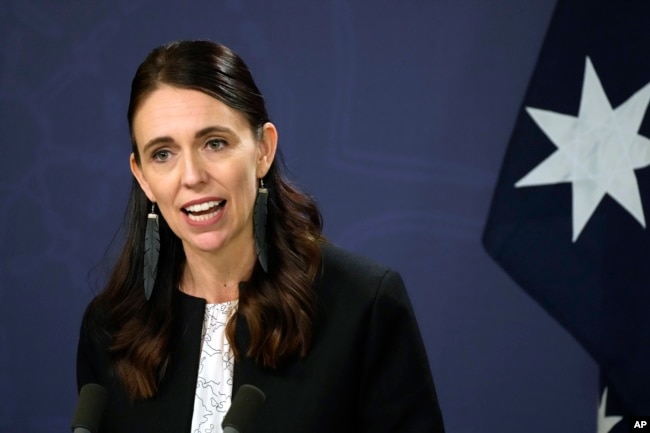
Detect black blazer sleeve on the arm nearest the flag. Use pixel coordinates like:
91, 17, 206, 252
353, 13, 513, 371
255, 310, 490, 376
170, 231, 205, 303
360, 271, 444, 433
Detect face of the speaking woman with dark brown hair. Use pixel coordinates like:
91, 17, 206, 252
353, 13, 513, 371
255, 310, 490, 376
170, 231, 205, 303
131, 86, 277, 257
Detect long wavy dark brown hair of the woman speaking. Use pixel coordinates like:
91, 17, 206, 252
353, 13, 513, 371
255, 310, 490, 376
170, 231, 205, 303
92, 41, 322, 399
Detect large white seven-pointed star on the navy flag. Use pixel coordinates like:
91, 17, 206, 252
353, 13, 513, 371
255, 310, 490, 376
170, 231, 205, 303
515, 57, 650, 242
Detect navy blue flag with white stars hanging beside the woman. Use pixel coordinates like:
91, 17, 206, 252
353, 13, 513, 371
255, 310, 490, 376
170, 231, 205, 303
483, 0, 650, 432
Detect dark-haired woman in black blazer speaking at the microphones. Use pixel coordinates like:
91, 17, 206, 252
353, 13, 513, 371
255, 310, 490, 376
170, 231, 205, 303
77, 41, 443, 433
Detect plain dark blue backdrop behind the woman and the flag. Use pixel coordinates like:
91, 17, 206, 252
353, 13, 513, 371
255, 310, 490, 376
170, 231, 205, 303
0, 0, 598, 433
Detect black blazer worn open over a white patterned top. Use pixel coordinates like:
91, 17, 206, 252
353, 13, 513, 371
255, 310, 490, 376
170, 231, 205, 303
77, 245, 444, 433
